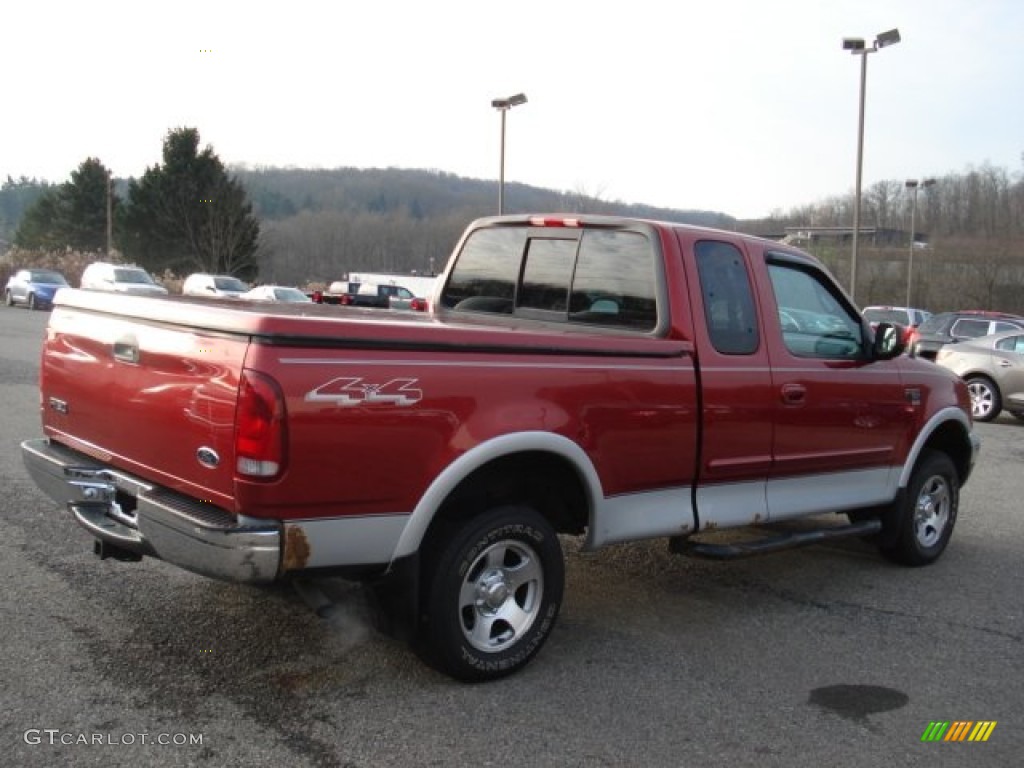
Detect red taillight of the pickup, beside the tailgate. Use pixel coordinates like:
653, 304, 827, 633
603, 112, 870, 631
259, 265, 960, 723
234, 371, 286, 479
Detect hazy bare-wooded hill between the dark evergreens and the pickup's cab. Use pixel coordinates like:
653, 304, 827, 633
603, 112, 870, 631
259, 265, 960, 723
230, 167, 735, 285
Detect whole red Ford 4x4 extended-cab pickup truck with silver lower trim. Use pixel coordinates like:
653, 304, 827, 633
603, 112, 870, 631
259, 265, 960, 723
23, 215, 978, 680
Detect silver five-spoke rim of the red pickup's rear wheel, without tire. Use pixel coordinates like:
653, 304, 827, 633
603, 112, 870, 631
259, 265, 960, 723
459, 541, 544, 653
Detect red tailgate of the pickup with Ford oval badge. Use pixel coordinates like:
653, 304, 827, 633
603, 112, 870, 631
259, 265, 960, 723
40, 300, 249, 511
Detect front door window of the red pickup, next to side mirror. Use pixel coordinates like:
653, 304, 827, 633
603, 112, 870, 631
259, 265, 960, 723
768, 256, 864, 359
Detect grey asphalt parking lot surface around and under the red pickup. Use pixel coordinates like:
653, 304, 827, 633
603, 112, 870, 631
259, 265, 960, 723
0, 308, 1024, 768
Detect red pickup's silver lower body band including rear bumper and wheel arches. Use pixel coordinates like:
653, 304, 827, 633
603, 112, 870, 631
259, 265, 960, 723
23, 409, 978, 583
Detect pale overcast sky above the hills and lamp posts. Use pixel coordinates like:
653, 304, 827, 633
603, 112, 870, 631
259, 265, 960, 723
0, 0, 1024, 218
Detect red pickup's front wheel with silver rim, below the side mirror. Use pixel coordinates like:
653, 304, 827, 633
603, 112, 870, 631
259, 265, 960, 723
881, 452, 959, 565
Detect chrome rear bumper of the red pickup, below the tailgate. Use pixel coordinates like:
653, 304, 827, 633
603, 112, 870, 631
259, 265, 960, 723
22, 438, 282, 583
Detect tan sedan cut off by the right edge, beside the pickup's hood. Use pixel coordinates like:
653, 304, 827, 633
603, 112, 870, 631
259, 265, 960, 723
935, 331, 1024, 421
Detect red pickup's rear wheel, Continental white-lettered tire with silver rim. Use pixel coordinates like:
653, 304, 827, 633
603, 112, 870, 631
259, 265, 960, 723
420, 505, 565, 682
